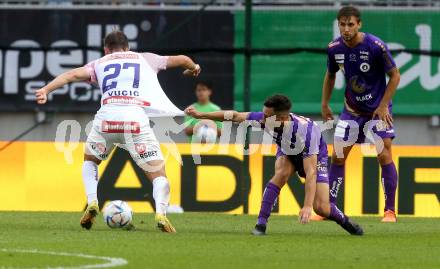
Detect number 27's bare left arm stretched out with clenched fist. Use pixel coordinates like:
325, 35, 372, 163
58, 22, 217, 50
35, 67, 90, 105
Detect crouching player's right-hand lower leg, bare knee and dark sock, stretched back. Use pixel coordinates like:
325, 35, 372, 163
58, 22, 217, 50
313, 182, 364, 235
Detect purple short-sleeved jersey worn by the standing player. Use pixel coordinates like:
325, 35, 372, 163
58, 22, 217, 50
327, 33, 396, 114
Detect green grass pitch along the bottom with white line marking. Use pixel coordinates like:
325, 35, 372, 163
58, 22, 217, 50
0, 212, 440, 269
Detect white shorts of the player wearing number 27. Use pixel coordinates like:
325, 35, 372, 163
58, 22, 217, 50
85, 118, 163, 165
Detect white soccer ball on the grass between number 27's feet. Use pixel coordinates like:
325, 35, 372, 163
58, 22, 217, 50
103, 200, 133, 228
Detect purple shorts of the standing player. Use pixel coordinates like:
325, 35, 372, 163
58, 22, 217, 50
335, 109, 395, 144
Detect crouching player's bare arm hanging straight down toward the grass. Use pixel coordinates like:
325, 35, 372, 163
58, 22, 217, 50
299, 155, 318, 224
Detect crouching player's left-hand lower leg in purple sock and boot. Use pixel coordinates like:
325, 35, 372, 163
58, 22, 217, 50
252, 182, 280, 235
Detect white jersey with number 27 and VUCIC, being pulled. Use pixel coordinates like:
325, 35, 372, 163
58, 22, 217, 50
85, 51, 183, 124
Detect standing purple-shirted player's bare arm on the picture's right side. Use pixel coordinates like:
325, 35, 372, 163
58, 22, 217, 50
373, 68, 400, 126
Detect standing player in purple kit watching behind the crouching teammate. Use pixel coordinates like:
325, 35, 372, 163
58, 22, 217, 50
322, 6, 400, 222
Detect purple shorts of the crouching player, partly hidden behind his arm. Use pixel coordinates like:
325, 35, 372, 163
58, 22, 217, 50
277, 147, 329, 184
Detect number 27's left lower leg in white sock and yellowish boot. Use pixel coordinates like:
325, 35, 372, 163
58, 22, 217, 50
80, 160, 99, 230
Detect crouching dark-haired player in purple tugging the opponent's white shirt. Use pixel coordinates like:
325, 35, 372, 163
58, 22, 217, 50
185, 95, 363, 235
